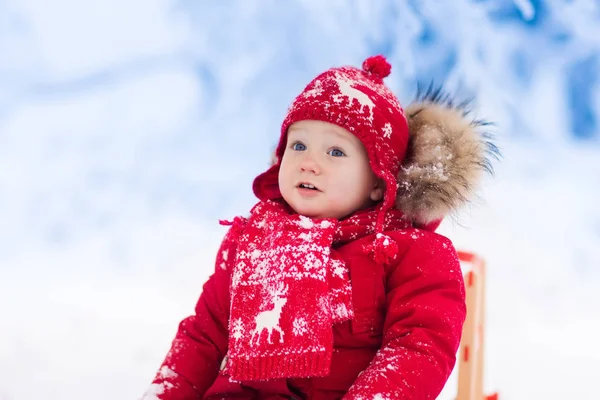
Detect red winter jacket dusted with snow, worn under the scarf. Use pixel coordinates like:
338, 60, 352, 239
144, 223, 466, 400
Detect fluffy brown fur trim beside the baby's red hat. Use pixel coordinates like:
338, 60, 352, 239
396, 87, 499, 225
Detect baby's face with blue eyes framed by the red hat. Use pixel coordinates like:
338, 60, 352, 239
279, 120, 383, 219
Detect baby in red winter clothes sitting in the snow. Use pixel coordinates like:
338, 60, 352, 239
144, 56, 494, 400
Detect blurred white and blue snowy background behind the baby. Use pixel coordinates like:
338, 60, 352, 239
0, 0, 600, 400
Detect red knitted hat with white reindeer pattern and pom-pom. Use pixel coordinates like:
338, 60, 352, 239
253, 55, 409, 239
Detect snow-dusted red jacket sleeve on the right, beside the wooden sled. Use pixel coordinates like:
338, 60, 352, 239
344, 230, 466, 400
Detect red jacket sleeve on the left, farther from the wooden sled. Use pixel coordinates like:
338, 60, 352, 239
142, 228, 235, 400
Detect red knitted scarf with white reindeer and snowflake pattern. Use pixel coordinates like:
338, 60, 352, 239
225, 201, 410, 381
